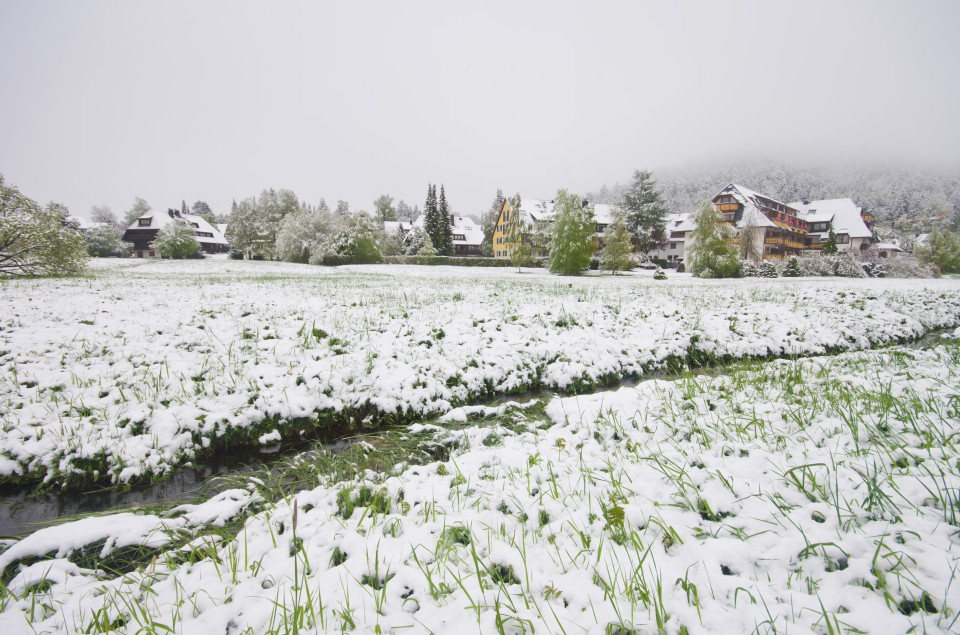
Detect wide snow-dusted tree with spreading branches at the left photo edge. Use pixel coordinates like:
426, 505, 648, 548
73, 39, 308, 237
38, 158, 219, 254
0, 174, 88, 276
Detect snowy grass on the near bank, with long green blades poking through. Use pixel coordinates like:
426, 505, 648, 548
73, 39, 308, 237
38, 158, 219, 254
0, 343, 960, 635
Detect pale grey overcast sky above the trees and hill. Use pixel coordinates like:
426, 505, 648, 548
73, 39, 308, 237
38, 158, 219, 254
0, 0, 960, 221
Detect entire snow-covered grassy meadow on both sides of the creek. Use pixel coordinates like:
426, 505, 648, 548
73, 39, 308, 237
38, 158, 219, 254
0, 261, 960, 634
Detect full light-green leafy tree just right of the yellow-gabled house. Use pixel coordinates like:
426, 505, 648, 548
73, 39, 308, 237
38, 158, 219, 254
550, 190, 596, 276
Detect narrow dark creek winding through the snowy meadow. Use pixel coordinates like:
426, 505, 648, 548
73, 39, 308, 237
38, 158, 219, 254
0, 331, 941, 538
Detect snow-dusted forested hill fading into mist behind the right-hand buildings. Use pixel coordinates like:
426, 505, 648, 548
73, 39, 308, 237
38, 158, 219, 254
588, 162, 960, 226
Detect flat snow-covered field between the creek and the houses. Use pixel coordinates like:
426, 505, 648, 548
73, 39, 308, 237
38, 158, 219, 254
0, 260, 960, 485
